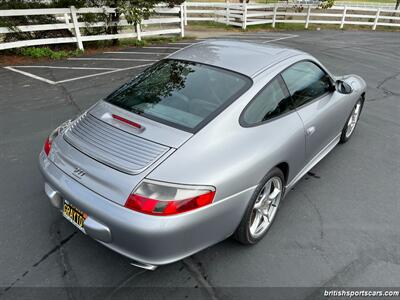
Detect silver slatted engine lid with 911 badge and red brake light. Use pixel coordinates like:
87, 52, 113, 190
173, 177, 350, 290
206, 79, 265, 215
50, 102, 191, 205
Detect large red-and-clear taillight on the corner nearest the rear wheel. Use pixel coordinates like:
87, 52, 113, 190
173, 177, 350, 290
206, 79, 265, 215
125, 181, 215, 216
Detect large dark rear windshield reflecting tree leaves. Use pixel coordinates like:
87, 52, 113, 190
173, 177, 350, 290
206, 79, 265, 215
105, 59, 251, 132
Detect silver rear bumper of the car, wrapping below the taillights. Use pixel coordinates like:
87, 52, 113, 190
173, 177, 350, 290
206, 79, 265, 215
39, 152, 254, 265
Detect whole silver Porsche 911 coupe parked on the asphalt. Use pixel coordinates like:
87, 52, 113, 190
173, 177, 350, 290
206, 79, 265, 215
39, 40, 366, 269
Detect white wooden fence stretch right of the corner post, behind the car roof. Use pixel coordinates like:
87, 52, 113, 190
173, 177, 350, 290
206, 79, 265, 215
184, 2, 400, 30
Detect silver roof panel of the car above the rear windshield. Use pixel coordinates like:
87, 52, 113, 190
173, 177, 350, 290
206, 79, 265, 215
168, 39, 304, 77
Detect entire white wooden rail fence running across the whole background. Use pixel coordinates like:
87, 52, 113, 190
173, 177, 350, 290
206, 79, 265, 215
0, 1, 400, 50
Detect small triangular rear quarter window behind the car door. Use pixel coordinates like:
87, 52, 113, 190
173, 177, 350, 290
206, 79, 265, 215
242, 76, 291, 125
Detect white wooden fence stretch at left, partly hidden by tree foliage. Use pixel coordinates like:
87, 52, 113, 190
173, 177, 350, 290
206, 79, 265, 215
0, 5, 184, 50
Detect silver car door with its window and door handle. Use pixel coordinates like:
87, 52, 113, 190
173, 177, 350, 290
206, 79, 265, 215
282, 61, 343, 162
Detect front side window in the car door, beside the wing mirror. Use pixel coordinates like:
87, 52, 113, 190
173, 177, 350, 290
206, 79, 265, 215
282, 61, 331, 107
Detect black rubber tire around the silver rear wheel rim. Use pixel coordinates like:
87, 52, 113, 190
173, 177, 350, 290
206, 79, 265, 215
234, 168, 285, 245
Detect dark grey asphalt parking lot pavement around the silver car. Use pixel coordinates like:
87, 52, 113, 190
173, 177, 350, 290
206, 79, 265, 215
0, 30, 400, 299
